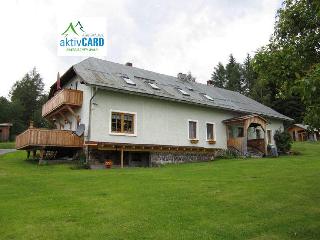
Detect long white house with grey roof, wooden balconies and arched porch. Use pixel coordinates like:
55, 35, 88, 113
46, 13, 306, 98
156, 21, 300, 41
17, 58, 291, 165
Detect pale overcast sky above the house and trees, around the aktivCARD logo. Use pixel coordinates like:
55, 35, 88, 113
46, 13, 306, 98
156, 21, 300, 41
0, 0, 281, 97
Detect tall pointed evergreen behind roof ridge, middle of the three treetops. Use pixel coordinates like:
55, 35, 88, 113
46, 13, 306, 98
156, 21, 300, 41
226, 54, 242, 92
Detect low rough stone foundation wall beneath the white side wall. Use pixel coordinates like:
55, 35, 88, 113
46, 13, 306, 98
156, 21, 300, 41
150, 152, 214, 166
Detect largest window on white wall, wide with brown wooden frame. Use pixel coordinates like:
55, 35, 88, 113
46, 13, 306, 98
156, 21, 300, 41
111, 112, 134, 134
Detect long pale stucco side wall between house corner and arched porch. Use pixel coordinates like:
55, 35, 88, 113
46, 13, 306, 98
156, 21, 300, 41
90, 90, 236, 148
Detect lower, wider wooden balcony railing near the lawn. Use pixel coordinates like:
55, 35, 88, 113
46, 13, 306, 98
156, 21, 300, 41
16, 128, 83, 150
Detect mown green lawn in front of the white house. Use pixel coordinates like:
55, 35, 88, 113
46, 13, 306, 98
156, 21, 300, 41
0, 143, 320, 240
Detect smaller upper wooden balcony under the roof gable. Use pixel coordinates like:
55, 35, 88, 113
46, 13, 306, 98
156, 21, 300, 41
42, 89, 83, 117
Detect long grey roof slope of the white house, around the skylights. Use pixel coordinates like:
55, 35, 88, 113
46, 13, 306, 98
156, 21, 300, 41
73, 58, 292, 120
